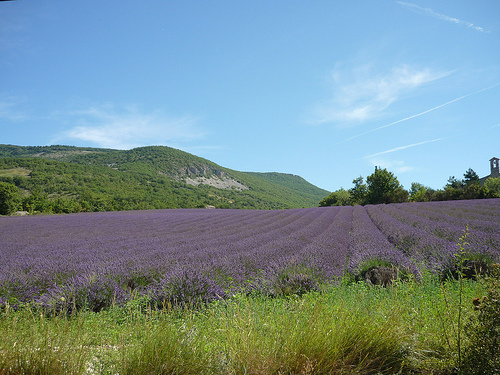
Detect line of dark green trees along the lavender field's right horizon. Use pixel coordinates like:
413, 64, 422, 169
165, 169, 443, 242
319, 167, 500, 207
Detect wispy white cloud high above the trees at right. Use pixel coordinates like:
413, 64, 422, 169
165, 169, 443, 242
311, 65, 451, 126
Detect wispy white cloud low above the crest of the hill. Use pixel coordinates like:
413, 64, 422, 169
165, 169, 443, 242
53, 104, 204, 149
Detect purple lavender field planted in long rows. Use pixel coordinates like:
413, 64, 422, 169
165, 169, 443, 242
0, 199, 500, 311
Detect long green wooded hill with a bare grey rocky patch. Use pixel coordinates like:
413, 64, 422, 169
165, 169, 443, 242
0, 145, 328, 212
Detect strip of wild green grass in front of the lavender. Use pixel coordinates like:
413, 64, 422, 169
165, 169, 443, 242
0, 275, 499, 375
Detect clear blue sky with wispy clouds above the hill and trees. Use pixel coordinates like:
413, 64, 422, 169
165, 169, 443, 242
0, 0, 500, 191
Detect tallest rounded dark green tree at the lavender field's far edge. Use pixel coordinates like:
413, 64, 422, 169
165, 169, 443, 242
366, 167, 408, 204
